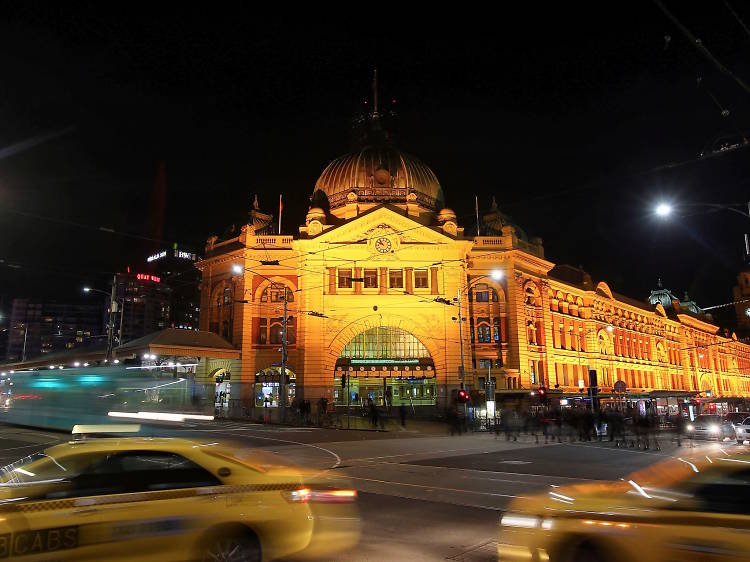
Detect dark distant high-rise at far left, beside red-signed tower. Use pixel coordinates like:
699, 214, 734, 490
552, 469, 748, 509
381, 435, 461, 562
6, 298, 106, 361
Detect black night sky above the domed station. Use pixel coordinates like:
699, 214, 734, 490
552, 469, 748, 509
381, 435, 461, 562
0, 0, 750, 324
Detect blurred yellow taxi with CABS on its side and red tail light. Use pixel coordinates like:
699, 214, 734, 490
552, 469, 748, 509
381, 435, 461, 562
0, 426, 359, 562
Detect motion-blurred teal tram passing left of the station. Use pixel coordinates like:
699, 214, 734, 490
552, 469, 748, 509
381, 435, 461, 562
0, 366, 213, 431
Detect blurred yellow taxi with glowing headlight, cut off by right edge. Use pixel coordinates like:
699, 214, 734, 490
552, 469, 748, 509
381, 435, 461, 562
498, 447, 750, 562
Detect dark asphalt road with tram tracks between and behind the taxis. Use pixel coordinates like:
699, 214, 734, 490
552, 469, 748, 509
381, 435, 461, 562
0, 422, 728, 562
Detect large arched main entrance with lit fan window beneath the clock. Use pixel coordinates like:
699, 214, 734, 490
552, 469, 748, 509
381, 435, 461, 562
334, 326, 437, 407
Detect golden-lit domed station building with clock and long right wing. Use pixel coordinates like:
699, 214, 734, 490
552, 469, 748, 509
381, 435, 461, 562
197, 113, 750, 413
